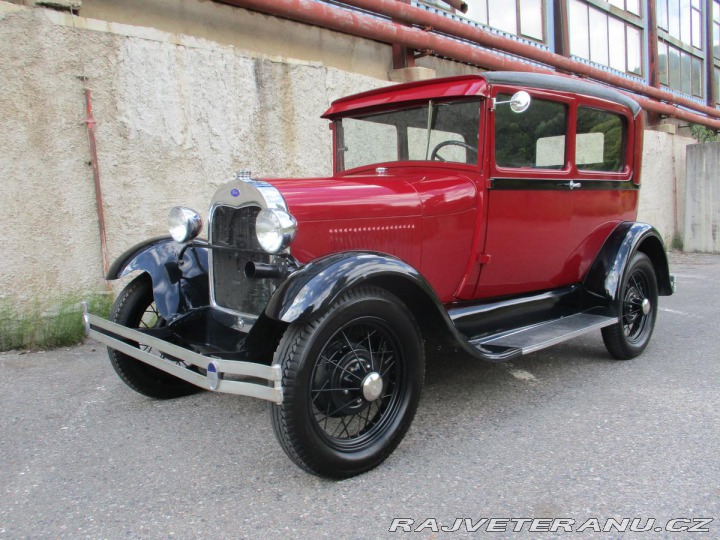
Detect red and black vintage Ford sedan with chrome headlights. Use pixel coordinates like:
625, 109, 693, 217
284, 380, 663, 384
85, 73, 673, 478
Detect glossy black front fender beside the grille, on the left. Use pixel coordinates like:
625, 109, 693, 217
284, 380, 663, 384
106, 237, 210, 321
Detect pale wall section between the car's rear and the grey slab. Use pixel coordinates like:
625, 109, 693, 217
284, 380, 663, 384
638, 131, 695, 244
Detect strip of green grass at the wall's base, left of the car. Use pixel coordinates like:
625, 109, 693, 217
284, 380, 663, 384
0, 293, 112, 351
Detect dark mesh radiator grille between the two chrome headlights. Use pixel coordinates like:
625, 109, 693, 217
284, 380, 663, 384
210, 206, 277, 315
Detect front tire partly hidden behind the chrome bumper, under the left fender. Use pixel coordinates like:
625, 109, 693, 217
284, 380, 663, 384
108, 274, 201, 399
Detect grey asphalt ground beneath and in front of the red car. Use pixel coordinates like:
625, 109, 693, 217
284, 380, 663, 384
0, 255, 720, 539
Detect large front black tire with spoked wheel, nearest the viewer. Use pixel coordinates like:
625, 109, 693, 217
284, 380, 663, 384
271, 287, 425, 478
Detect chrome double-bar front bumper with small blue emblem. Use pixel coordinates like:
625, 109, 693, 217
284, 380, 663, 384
83, 304, 283, 403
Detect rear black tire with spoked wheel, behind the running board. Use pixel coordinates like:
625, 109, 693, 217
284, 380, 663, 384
602, 252, 658, 360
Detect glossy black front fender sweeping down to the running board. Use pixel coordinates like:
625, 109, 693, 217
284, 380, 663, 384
264, 251, 506, 361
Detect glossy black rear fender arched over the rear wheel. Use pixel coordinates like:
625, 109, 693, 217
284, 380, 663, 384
583, 221, 672, 306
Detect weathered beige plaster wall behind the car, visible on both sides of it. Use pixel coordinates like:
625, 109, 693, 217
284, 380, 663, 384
0, 0, 687, 320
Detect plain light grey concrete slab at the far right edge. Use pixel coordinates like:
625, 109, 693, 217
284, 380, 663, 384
685, 142, 720, 253
